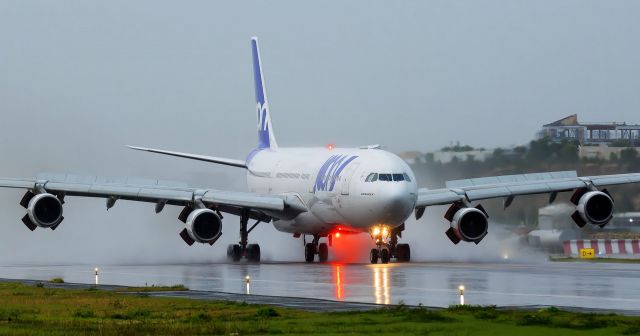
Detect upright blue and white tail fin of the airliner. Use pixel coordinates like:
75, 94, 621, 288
251, 37, 278, 149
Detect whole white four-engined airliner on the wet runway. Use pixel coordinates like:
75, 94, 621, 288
0, 38, 640, 263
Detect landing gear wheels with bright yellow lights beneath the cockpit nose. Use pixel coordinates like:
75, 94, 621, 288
369, 224, 411, 264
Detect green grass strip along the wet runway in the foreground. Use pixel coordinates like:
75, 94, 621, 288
0, 283, 640, 336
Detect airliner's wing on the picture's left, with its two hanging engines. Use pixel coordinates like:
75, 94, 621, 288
0, 174, 307, 245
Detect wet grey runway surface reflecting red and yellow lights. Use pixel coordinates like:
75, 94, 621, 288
0, 262, 640, 315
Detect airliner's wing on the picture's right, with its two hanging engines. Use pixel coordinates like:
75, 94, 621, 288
416, 171, 640, 244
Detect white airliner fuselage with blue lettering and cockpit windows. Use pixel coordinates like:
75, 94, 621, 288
247, 148, 417, 234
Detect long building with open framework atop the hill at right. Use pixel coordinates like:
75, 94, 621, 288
537, 114, 640, 147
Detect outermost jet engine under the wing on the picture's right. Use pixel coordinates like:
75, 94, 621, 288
571, 189, 613, 227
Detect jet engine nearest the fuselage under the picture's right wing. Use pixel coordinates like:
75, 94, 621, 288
444, 202, 489, 244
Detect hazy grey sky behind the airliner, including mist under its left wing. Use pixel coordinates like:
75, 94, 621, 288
0, 0, 640, 266
